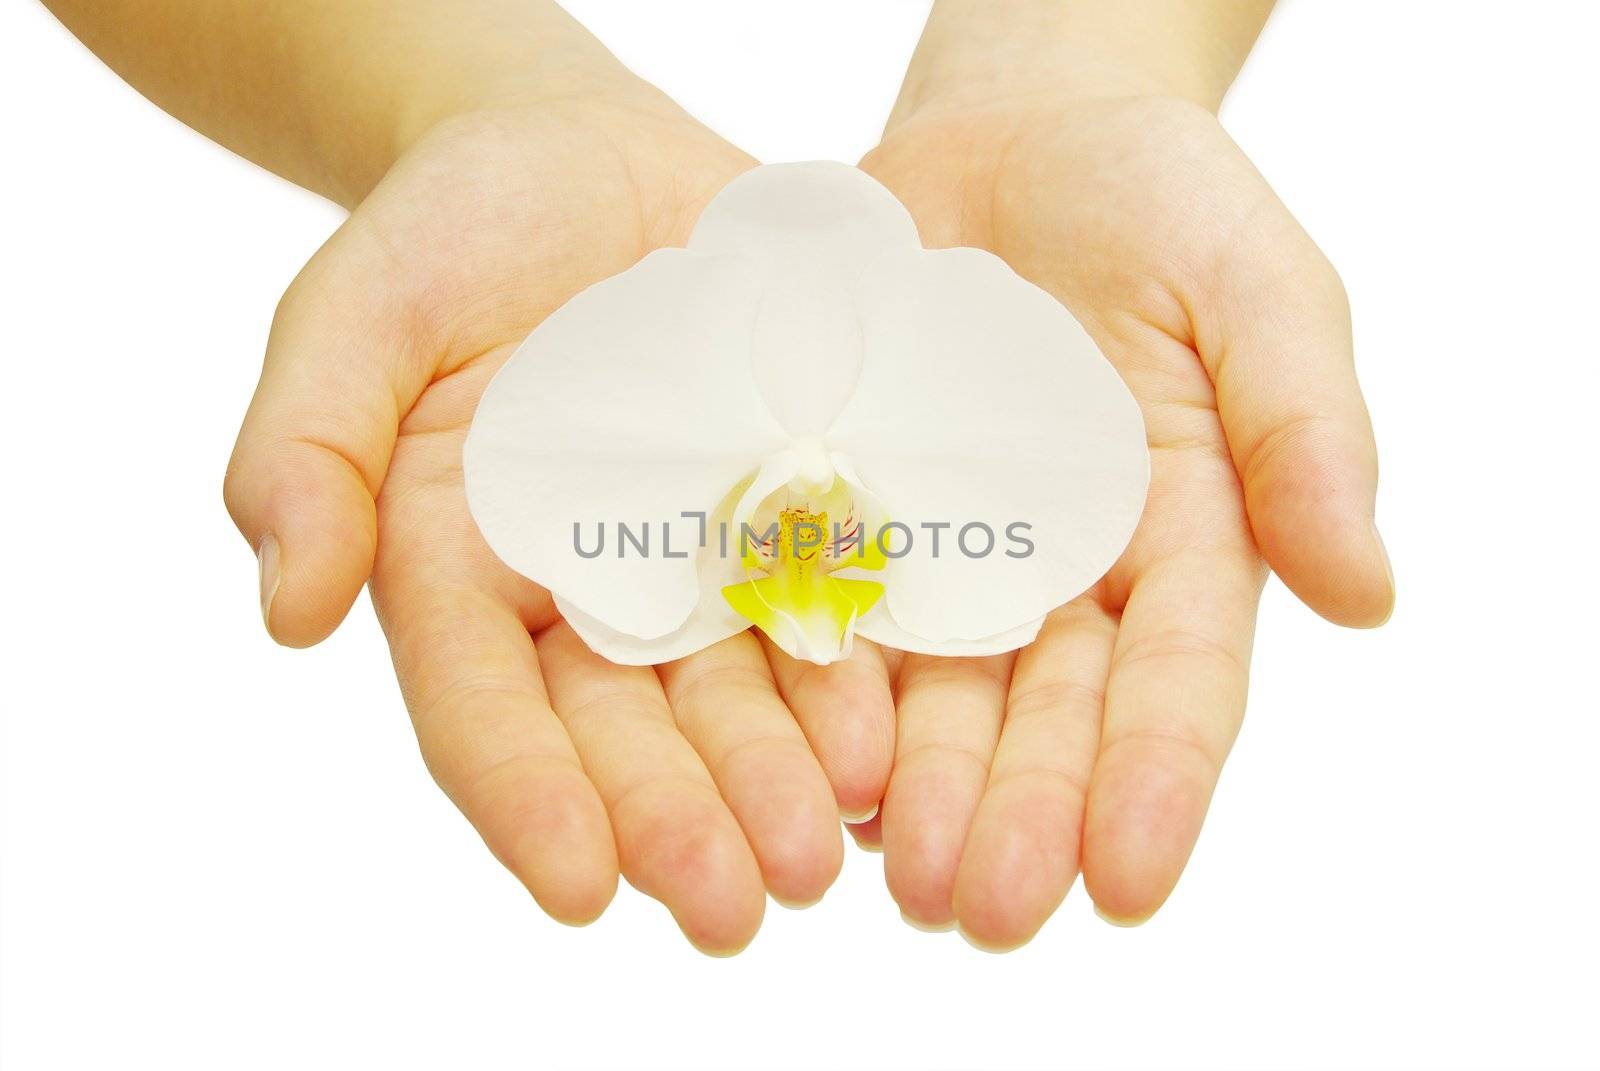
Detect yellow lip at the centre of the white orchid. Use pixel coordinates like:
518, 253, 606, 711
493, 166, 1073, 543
722, 507, 883, 664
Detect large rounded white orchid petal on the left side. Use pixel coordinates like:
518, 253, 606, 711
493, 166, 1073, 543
464, 250, 789, 639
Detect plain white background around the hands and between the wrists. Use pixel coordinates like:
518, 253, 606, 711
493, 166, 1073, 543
0, 0, 1600, 1071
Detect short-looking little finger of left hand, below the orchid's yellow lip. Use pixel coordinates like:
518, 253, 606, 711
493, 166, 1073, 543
762, 636, 894, 823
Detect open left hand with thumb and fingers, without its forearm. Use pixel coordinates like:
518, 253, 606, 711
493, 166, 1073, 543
226, 86, 893, 953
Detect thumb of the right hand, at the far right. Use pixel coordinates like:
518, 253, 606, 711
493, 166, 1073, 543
1200, 203, 1394, 628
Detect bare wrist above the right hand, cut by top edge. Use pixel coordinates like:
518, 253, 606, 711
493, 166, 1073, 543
888, 0, 1272, 130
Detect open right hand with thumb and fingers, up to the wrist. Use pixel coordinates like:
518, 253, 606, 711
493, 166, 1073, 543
858, 89, 1394, 948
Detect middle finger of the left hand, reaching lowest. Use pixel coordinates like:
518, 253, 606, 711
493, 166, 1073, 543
538, 623, 766, 954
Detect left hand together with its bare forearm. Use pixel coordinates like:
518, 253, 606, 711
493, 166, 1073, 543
51, 0, 893, 954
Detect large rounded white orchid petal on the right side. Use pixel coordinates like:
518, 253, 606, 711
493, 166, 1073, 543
827, 250, 1149, 644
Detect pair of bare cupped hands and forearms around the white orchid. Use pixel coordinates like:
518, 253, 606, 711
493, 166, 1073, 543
37, 0, 1392, 953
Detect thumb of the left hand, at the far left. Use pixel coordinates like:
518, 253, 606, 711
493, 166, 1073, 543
222, 221, 429, 647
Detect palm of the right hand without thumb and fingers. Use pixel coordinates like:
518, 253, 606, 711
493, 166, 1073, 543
966, 102, 1270, 615
